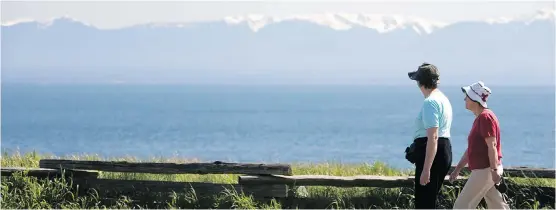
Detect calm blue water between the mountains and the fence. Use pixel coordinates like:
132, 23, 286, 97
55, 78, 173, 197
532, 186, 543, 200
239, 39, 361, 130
1, 85, 555, 168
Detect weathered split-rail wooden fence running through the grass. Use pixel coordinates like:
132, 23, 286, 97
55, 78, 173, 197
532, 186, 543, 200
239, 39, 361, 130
1, 159, 555, 198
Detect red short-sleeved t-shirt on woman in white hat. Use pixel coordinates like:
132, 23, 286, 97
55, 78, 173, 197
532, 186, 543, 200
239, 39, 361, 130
467, 109, 502, 170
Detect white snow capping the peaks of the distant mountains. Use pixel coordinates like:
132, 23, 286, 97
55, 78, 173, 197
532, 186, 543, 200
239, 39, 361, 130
2, 9, 556, 34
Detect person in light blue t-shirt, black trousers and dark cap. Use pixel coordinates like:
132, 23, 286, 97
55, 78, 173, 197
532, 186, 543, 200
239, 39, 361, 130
408, 63, 452, 209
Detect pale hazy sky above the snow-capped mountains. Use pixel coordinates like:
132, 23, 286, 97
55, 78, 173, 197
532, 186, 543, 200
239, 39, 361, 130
1, 0, 555, 28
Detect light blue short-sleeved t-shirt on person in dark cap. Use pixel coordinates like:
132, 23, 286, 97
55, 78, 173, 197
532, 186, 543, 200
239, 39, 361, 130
413, 91, 452, 139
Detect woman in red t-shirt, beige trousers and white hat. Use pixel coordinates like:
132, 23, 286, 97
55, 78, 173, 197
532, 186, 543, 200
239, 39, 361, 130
450, 81, 509, 209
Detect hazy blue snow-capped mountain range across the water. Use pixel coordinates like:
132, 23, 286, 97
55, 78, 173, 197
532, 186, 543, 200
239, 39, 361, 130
1, 10, 556, 84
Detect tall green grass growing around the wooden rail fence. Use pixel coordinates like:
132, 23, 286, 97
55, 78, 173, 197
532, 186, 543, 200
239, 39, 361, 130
0, 152, 555, 209
